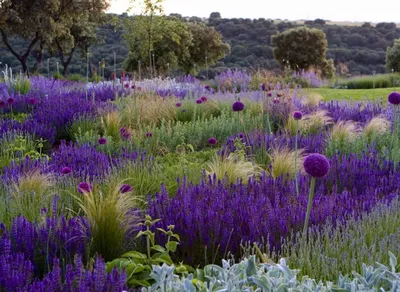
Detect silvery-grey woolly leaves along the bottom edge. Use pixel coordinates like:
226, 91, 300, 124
143, 252, 400, 292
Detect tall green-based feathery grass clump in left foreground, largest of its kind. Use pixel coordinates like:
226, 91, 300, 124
75, 183, 140, 261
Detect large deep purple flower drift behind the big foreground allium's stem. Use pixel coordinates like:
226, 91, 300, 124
148, 153, 400, 263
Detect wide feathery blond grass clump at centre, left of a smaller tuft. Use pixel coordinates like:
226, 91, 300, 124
206, 152, 261, 183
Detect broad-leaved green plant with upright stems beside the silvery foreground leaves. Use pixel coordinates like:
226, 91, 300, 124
107, 215, 192, 288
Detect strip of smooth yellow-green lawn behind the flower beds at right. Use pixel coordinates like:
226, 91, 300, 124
304, 87, 400, 101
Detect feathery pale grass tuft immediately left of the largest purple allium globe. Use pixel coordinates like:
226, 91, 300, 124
269, 147, 304, 179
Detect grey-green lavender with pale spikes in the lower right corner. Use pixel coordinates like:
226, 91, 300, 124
276, 200, 400, 280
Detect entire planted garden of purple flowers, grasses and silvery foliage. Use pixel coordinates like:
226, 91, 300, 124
0, 70, 400, 291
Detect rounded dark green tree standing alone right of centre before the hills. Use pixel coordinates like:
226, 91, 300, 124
272, 26, 328, 74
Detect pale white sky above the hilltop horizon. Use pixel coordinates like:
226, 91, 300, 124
110, 0, 400, 23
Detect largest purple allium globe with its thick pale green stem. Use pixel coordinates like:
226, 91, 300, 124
303, 153, 330, 233
